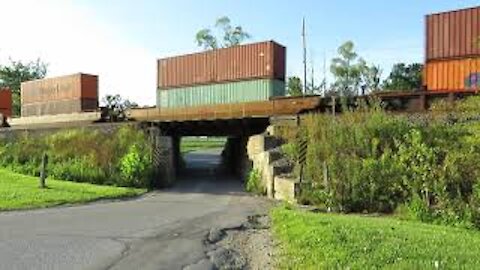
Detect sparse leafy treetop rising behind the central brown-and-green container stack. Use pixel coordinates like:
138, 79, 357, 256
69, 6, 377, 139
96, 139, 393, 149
195, 16, 250, 50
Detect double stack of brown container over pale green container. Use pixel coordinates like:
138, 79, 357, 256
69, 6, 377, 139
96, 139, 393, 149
157, 41, 286, 109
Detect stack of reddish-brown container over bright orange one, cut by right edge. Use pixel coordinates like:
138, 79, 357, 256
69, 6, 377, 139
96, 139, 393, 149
424, 7, 480, 92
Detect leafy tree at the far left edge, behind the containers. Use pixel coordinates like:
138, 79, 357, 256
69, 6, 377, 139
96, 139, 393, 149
0, 59, 47, 116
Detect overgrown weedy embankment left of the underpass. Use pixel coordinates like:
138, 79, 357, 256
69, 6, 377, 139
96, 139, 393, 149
0, 126, 154, 187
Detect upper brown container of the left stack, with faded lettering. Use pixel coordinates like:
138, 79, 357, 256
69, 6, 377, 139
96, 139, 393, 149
21, 73, 98, 105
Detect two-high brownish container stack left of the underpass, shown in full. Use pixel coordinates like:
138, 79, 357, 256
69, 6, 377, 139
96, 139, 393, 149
21, 73, 98, 117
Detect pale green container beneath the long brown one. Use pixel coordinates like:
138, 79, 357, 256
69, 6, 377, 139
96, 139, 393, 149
157, 79, 285, 108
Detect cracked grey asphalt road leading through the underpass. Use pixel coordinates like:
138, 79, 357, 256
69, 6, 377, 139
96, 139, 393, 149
0, 151, 265, 270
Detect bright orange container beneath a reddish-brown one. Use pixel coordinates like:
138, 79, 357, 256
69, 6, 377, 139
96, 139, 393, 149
424, 57, 480, 92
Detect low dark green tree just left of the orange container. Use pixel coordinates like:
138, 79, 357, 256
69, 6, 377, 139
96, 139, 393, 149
383, 63, 423, 91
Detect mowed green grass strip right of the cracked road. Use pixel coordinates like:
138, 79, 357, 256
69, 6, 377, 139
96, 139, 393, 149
271, 207, 480, 269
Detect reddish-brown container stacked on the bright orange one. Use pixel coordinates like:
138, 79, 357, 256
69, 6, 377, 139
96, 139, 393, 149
426, 7, 480, 62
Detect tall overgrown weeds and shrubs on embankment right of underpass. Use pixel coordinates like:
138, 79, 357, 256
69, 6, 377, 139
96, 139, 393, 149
282, 97, 480, 227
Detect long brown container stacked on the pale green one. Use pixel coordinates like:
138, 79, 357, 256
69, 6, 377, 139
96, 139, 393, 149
157, 41, 286, 89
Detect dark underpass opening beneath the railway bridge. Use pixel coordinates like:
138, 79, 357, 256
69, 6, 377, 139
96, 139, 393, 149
144, 118, 270, 192
